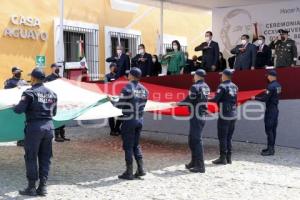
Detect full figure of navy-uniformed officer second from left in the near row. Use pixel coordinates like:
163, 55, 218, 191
109, 67, 149, 180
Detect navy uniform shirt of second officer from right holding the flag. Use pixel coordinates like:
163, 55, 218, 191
210, 80, 238, 117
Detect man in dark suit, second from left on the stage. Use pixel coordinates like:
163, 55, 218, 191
131, 44, 152, 77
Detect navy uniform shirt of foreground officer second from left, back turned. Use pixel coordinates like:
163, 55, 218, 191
115, 81, 149, 120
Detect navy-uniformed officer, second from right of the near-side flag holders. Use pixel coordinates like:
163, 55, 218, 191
210, 69, 238, 165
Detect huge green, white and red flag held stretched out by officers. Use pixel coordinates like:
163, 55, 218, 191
0, 79, 263, 142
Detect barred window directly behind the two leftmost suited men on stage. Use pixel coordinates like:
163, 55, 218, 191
109, 31, 141, 55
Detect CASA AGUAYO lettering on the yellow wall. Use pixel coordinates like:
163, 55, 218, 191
3, 15, 48, 41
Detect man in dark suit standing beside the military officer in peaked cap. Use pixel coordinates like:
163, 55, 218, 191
255, 35, 272, 69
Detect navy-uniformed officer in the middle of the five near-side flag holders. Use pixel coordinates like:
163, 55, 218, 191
175, 69, 210, 173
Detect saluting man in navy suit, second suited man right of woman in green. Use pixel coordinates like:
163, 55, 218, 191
231, 34, 256, 70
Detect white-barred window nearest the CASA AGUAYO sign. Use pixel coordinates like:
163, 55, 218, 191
64, 26, 99, 80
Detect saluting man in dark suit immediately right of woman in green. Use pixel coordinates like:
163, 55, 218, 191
195, 31, 220, 71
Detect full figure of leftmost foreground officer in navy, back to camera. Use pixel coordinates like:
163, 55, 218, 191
14, 68, 57, 196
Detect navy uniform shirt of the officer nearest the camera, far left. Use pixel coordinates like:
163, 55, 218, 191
14, 83, 57, 122
